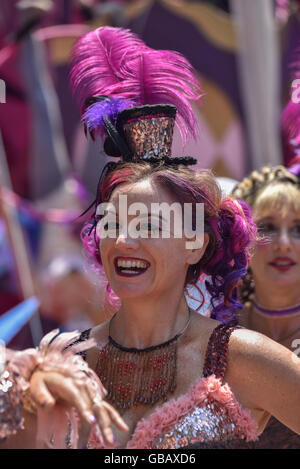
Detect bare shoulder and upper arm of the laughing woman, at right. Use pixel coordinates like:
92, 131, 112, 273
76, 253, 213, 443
225, 329, 300, 434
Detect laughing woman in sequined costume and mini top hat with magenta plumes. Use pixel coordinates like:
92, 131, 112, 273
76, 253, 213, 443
59, 27, 300, 449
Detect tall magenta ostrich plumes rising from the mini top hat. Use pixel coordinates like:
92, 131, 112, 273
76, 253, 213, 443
71, 27, 203, 144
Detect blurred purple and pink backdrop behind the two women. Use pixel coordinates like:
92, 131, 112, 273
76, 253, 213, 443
0, 0, 300, 349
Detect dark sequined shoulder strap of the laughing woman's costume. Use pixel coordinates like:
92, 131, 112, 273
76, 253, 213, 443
203, 323, 238, 379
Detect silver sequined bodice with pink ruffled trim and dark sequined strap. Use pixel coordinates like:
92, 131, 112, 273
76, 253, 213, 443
74, 324, 258, 449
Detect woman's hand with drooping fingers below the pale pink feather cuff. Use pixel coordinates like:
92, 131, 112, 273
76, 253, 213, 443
30, 369, 128, 445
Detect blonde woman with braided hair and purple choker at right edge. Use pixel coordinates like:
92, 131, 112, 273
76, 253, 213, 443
233, 165, 300, 449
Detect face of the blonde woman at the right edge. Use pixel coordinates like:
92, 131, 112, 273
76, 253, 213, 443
251, 209, 300, 294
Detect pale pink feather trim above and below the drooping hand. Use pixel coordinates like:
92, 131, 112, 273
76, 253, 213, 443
8, 330, 106, 449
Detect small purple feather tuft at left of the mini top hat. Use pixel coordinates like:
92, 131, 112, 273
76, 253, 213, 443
82, 97, 135, 137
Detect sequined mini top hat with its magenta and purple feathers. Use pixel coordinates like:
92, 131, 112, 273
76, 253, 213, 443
70, 27, 202, 165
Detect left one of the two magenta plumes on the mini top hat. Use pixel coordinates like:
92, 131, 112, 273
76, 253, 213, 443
70, 26, 146, 112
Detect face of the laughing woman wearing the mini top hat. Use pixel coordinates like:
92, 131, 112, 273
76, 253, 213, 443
97, 180, 208, 299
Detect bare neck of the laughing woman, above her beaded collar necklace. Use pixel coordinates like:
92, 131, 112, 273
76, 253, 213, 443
110, 295, 189, 348
